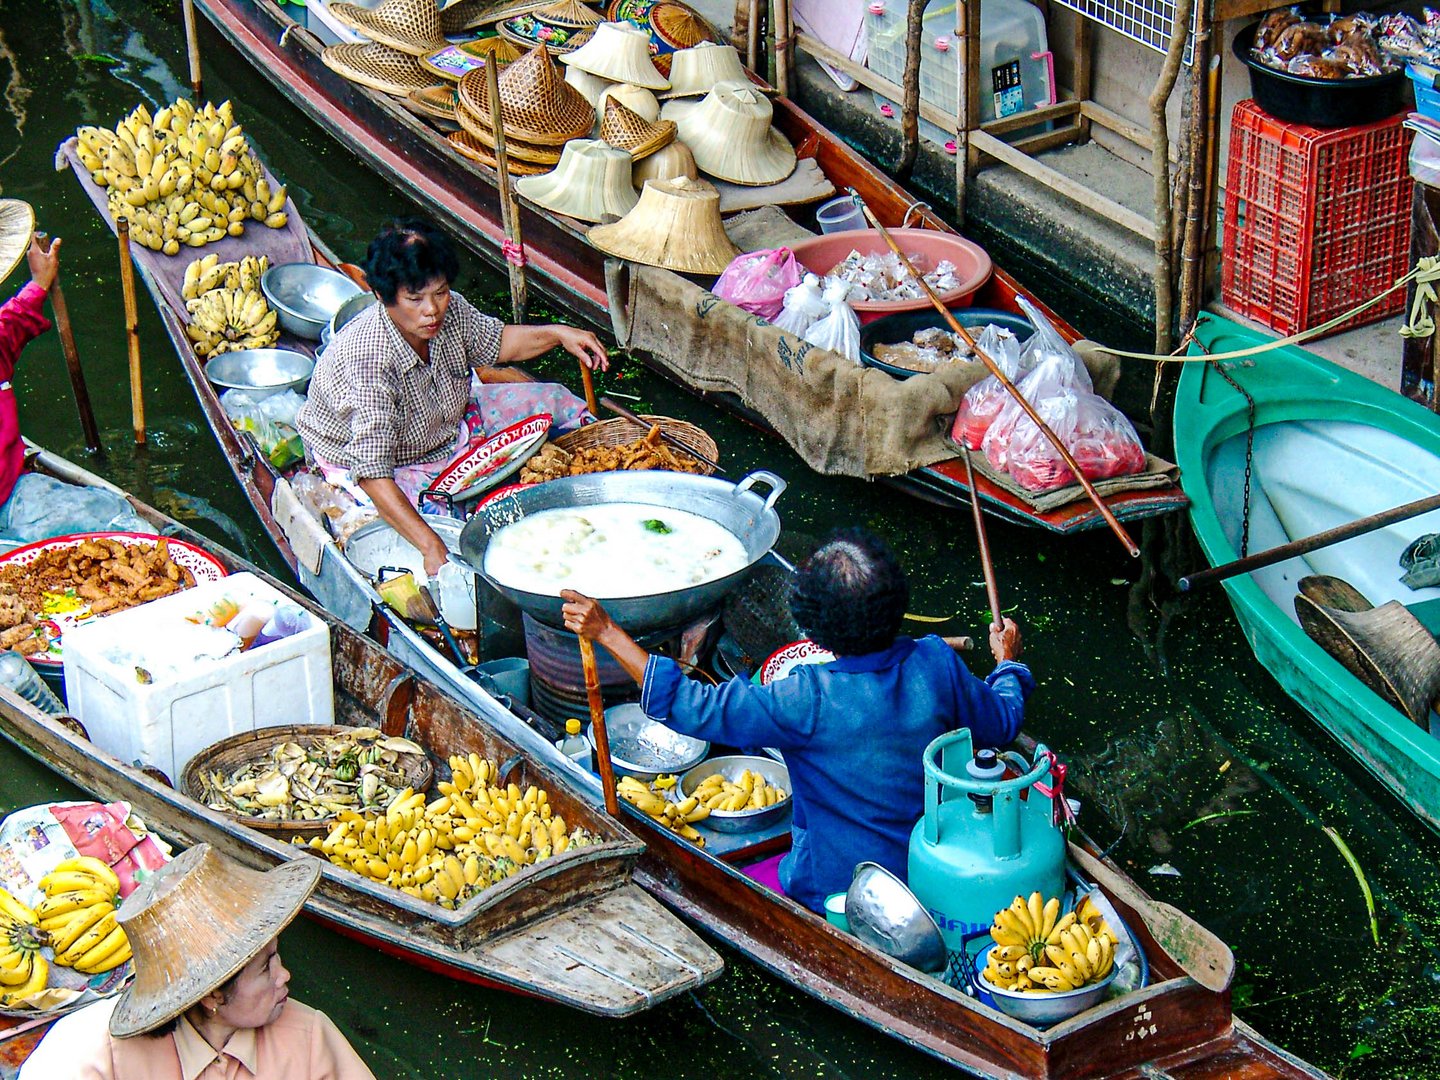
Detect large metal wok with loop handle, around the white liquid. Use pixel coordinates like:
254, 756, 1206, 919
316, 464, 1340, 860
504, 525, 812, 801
451, 469, 785, 634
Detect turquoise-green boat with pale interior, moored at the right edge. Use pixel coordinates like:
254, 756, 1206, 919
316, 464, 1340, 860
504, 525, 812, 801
1175, 315, 1440, 829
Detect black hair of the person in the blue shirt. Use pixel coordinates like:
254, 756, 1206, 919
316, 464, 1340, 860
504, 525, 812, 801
791, 528, 910, 657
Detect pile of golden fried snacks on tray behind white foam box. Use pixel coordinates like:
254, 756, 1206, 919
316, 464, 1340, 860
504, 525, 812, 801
0, 537, 194, 655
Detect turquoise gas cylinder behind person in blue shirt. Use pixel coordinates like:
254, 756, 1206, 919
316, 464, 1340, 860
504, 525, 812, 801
909, 729, 1066, 952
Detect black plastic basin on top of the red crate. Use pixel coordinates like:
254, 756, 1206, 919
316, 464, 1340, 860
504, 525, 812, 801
1231, 23, 1410, 128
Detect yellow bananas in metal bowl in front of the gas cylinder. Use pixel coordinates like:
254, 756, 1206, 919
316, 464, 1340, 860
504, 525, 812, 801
985, 893, 1119, 994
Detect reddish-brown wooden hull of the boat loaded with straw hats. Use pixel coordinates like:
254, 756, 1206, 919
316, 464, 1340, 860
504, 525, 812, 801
185, 0, 1185, 533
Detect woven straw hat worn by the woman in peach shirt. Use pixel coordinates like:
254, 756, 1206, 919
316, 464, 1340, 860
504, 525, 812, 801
109, 844, 320, 1038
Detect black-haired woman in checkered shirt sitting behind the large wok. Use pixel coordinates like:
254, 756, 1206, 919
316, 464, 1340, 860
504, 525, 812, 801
298, 219, 609, 577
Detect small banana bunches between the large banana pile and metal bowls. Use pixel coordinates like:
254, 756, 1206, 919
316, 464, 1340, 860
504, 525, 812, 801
180, 255, 279, 360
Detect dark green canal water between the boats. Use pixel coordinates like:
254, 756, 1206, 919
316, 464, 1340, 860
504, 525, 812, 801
0, 0, 1440, 1080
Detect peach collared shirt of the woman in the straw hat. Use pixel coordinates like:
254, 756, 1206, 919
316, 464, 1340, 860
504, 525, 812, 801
20, 998, 374, 1080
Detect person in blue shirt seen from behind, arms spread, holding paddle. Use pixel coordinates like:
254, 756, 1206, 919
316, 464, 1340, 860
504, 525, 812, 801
562, 528, 1035, 912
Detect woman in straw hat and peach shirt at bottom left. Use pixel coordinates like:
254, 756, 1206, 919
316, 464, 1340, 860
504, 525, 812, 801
20, 844, 374, 1080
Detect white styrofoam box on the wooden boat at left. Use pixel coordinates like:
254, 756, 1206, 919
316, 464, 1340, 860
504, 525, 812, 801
65, 573, 336, 785
